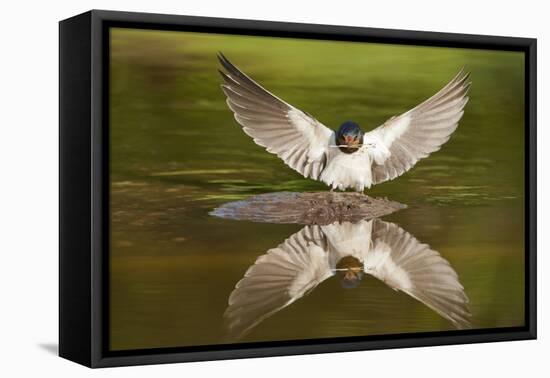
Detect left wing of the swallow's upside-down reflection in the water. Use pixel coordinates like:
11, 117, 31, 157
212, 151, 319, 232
224, 226, 332, 338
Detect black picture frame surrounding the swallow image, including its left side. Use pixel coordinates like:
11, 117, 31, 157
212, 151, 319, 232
59, 10, 537, 368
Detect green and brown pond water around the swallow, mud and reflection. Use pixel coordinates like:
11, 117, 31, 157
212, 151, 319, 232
110, 29, 525, 350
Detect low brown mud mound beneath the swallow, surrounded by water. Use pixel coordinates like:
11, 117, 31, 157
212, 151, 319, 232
210, 192, 407, 225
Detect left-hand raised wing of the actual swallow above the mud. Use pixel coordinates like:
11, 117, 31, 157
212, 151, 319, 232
218, 54, 333, 179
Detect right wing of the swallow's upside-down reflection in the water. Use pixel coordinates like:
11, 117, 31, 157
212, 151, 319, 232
364, 220, 471, 328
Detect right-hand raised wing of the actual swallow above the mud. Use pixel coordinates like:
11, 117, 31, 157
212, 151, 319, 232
363, 70, 470, 184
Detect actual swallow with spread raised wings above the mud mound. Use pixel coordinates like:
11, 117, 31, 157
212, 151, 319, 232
218, 54, 470, 191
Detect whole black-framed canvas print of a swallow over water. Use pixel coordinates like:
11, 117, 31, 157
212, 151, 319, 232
59, 10, 536, 367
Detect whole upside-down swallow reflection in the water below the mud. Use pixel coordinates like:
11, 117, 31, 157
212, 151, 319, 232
224, 219, 471, 339
